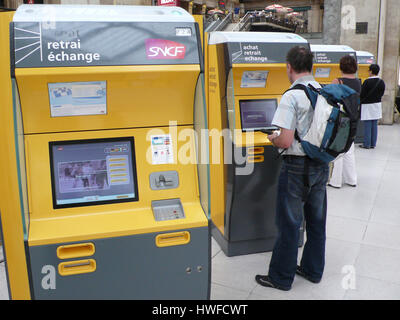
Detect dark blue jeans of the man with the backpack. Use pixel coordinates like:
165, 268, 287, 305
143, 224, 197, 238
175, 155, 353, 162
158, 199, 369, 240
268, 156, 329, 288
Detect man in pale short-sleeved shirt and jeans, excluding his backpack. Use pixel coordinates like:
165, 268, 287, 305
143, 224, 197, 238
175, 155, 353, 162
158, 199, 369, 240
256, 47, 329, 291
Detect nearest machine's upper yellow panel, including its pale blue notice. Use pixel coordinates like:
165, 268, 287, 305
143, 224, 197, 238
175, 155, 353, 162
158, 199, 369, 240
16, 65, 200, 134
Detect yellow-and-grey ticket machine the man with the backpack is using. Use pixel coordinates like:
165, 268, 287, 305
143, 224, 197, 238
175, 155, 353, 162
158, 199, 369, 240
205, 32, 309, 256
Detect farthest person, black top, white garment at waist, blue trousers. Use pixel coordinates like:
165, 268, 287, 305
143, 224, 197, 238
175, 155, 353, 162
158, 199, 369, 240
360, 64, 386, 149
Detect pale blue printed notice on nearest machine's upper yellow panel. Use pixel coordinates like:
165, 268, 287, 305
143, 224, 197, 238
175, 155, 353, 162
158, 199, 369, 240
48, 81, 107, 117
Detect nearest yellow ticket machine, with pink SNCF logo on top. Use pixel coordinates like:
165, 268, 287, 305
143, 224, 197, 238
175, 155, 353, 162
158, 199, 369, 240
0, 5, 211, 299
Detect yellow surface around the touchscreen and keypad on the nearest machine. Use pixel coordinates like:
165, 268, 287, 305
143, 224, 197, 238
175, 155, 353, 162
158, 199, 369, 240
26, 127, 208, 245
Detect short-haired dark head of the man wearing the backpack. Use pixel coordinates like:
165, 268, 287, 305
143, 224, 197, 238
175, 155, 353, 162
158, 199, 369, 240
286, 46, 314, 83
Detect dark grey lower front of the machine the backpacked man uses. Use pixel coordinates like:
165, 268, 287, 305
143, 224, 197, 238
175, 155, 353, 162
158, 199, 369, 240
225, 145, 282, 241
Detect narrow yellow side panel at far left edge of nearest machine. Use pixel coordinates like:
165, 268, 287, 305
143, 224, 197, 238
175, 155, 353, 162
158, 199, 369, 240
0, 12, 31, 300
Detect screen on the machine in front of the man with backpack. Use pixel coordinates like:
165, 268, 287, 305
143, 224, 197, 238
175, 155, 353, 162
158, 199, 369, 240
239, 99, 278, 131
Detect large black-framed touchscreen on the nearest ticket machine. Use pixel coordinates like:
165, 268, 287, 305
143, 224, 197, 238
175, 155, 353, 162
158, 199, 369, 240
49, 137, 138, 209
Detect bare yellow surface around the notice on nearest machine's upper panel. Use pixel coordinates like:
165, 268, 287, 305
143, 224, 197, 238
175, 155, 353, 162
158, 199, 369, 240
15, 65, 200, 134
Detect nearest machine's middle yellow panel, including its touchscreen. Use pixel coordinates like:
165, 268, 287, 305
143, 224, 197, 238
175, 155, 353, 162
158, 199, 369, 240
26, 127, 207, 245
